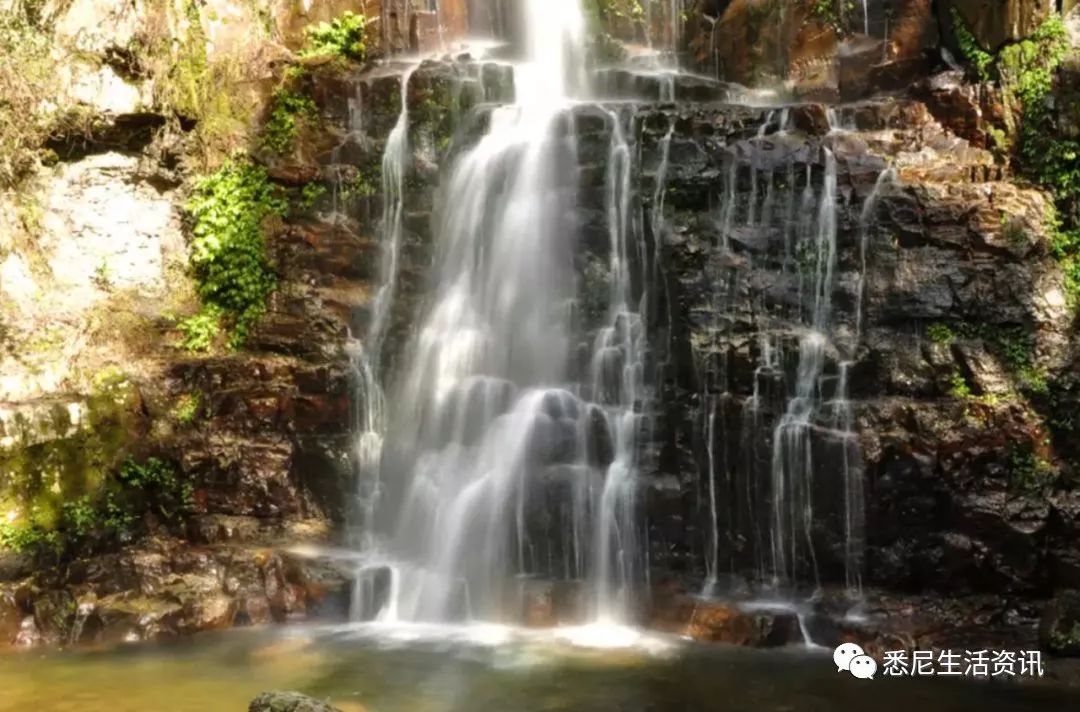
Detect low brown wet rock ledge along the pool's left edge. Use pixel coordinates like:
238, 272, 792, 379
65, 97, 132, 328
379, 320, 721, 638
0, 534, 352, 647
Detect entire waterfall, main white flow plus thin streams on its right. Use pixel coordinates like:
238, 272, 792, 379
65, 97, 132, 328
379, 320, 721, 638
345, 0, 885, 635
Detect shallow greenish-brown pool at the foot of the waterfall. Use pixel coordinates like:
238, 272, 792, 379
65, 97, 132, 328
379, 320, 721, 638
0, 628, 1080, 712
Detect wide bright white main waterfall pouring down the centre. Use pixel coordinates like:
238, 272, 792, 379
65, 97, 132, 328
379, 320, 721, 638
360, 0, 645, 622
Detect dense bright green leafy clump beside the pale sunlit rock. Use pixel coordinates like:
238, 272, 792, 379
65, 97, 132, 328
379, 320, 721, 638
180, 158, 287, 350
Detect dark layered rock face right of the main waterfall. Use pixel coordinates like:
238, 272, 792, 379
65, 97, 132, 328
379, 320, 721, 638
557, 93, 1075, 609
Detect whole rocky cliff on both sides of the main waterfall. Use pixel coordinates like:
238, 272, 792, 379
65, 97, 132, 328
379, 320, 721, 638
0, 0, 1080, 656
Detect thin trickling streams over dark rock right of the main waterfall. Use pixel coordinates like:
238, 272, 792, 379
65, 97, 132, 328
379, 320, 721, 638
698, 110, 888, 605
